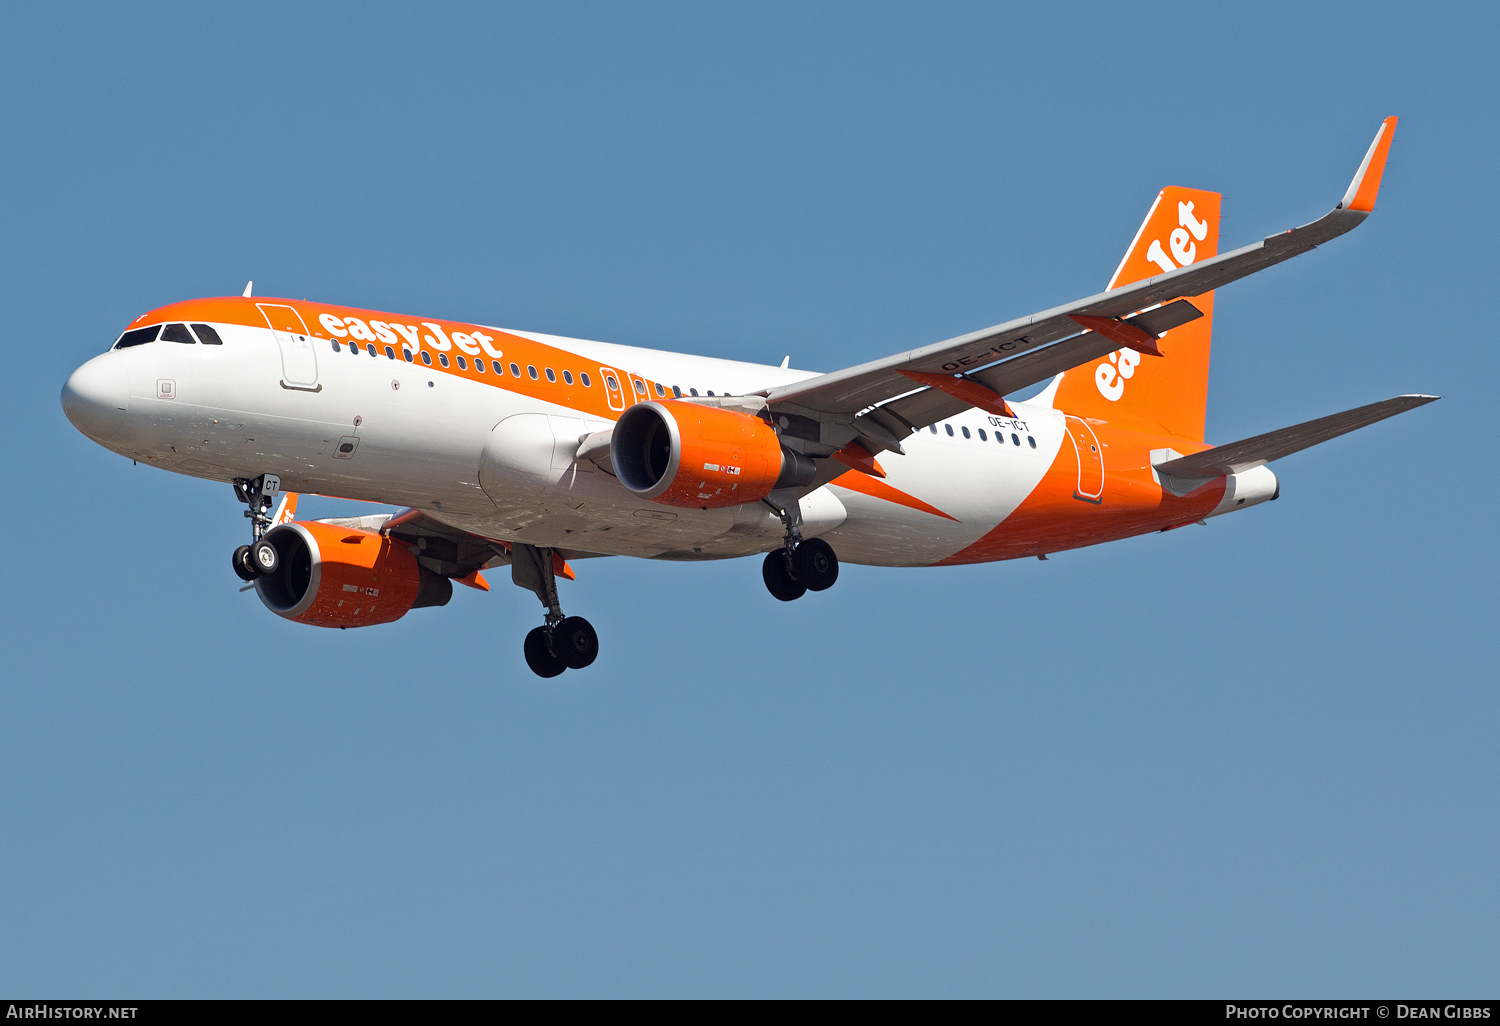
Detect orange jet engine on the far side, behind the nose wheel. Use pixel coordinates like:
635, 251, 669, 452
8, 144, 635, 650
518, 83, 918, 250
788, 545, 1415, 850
255, 521, 453, 627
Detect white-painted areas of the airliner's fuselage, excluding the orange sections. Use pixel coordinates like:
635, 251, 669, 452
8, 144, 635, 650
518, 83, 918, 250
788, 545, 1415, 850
65, 316, 1067, 566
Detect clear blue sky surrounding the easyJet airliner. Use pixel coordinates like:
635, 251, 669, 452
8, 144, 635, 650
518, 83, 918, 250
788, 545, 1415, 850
0, 3, 1500, 998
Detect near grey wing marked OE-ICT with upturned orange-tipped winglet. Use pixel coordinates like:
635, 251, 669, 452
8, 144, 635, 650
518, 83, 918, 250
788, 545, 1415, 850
764, 117, 1397, 452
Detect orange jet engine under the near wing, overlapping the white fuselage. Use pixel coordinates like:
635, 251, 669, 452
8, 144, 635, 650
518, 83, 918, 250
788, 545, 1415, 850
609, 399, 818, 510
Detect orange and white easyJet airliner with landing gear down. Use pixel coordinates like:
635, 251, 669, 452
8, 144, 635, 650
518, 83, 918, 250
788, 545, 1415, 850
62, 117, 1437, 678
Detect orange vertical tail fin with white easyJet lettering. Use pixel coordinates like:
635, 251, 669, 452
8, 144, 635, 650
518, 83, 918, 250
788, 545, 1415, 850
1053, 186, 1220, 441
